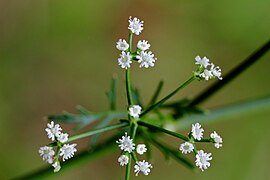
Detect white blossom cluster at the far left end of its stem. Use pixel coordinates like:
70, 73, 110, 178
38, 121, 77, 172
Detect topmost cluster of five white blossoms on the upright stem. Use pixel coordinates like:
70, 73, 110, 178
116, 17, 157, 69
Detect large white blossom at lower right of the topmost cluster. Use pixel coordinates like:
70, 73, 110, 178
136, 51, 157, 68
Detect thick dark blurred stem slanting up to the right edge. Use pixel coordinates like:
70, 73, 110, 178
188, 40, 270, 107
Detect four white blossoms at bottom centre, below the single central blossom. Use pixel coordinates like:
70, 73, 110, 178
116, 132, 152, 176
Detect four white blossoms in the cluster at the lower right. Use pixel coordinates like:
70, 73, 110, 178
179, 123, 222, 171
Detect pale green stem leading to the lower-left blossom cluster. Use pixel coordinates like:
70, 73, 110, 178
67, 122, 129, 143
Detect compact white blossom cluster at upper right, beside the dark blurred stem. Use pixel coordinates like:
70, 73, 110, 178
194, 56, 222, 81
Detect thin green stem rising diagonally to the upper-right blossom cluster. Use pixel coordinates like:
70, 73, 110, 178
140, 76, 195, 117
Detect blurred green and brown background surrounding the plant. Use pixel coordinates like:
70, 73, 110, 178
0, 0, 270, 180
